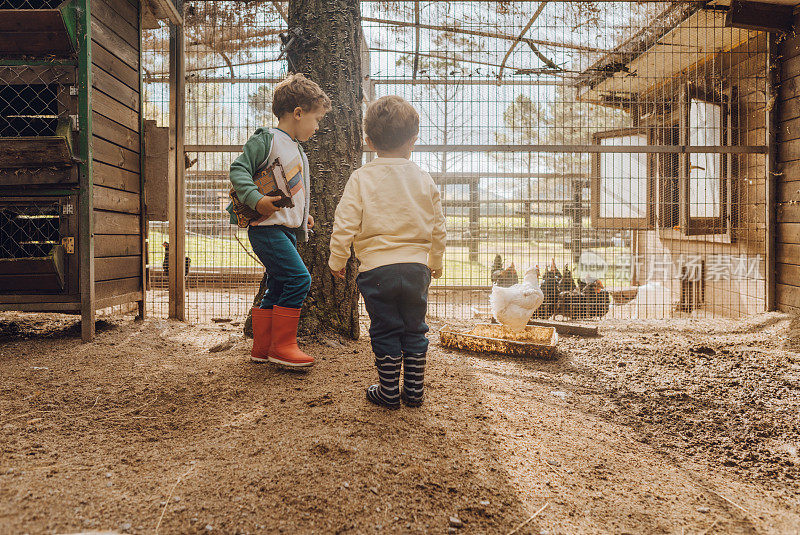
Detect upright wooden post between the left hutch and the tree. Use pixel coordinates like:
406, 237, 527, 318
169, 0, 186, 321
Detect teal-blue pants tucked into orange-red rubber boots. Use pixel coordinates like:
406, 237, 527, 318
247, 225, 311, 308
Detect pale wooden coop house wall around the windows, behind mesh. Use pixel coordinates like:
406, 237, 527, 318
637, 33, 767, 316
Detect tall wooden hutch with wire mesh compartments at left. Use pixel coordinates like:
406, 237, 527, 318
0, 0, 181, 340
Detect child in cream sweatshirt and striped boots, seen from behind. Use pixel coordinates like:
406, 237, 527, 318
328, 96, 447, 409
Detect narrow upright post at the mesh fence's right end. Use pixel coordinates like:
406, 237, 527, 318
764, 33, 779, 311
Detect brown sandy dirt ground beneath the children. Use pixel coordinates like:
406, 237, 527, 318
0, 314, 800, 535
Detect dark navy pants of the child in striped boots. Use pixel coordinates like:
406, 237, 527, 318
356, 263, 431, 356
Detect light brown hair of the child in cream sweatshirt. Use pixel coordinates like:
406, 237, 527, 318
364, 95, 419, 150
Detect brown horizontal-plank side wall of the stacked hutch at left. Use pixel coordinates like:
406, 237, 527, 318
91, 0, 142, 303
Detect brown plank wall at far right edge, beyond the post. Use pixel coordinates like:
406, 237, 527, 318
775, 16, 800, 312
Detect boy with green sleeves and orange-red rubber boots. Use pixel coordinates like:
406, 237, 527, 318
228, 74, 331, 367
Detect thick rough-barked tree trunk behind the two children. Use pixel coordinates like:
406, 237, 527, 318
287, 0, 362, 338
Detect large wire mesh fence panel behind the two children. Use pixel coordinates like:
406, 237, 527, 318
144, 0, 769, 321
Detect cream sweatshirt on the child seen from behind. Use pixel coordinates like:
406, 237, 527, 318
328, 158, 447, 271
